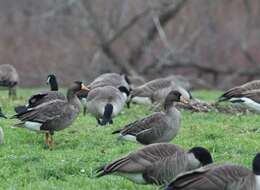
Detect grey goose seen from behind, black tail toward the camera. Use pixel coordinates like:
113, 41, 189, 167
86, 86, 129, 125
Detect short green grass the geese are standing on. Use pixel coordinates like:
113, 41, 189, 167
0, 90, 260, 190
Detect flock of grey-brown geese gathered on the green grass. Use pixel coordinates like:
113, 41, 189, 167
0, 68, 260, 190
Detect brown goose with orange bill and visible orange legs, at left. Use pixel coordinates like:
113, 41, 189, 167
12, 81, 88, 146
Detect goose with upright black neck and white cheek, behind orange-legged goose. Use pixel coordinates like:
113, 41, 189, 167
15, 74, 66, 113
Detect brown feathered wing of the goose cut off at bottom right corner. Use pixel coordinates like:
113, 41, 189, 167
167, 164, 251, 190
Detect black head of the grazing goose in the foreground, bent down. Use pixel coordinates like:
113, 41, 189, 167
188, 147, 213, 166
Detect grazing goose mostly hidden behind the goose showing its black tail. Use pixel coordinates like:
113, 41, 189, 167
78, 73, 131, 115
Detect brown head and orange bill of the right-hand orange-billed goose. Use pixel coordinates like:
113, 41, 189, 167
164, 90, 189, 110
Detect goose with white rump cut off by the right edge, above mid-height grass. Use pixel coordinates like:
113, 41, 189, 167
218, 80, 260, 112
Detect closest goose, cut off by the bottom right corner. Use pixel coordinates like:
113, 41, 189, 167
166, 153, 260, 190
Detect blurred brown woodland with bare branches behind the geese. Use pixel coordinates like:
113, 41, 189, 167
0, 0, 260, 89
